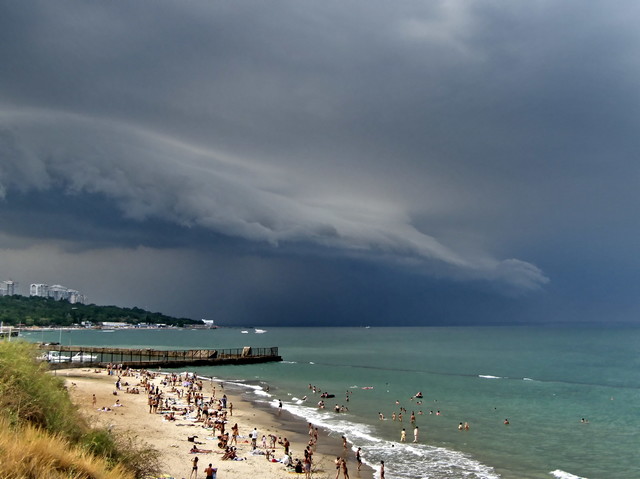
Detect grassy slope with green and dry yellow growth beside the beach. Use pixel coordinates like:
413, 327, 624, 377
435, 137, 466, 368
0, 341, 158, 479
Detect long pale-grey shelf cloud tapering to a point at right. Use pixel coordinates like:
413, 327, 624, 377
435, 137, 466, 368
0, 111, 545, 288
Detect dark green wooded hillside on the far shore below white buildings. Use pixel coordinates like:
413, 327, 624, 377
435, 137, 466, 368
0, 295, 202, 327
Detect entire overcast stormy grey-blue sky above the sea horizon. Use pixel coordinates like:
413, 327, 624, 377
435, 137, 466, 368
0, 0, 640, 325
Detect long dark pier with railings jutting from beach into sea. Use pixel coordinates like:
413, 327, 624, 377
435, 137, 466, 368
38, 344, 282, 369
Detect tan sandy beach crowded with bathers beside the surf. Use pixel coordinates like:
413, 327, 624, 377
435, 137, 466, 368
56, 369, 373, 479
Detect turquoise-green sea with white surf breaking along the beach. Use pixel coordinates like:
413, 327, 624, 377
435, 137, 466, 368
24, 326, 640, 479
